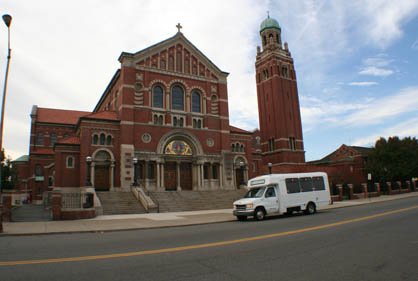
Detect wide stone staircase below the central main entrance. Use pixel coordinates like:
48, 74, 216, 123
150, 189, 246, 213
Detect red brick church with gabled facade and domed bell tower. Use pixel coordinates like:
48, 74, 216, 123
14, 17, 305, 202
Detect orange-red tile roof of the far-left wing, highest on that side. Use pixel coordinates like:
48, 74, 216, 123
37, 107, 91, 125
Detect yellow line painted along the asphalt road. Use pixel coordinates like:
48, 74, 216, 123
0, 203, 418, 266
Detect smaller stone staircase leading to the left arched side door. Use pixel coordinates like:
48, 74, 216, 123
96, 191, 147, 215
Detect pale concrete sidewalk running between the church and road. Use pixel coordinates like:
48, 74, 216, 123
0, 192, 418, 237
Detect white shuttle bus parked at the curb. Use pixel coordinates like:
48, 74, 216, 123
233, 172, 331, 220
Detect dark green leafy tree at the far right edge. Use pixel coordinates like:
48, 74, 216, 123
366, 137, 418, 181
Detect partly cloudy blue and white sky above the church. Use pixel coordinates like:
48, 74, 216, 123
0, 0, 418, 161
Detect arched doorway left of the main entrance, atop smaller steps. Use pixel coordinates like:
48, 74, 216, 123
93, 150, 111, 191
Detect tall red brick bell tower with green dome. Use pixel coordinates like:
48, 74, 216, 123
255, 16, 305, 166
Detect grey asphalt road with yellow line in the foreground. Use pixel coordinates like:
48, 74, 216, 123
0, 197, 418, 281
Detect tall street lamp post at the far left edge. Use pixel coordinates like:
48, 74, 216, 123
0, 14, 12, 232
